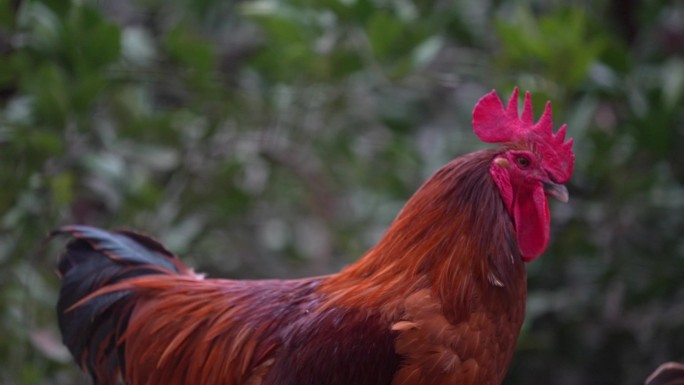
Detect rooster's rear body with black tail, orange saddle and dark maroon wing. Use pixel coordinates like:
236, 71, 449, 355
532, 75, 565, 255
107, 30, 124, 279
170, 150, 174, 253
54, 226, 399, 385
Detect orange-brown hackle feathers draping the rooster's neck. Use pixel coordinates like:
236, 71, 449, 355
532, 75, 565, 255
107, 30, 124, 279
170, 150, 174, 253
320, 149, 524, 320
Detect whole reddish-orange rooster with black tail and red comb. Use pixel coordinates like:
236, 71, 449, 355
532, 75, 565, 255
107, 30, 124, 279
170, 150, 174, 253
52, 89, 574, 385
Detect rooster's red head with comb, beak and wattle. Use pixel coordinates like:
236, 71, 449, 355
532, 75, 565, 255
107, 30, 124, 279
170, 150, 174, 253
473, 88, 575, 262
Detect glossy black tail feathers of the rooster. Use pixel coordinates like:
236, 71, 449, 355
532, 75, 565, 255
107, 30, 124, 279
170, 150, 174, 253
50, 226, 191, 385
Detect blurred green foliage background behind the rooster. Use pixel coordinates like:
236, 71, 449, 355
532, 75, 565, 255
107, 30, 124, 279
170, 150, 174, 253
0, 0, 684, 385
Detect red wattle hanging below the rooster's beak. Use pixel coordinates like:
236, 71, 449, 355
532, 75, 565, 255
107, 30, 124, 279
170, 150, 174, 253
513, 184, 551, 262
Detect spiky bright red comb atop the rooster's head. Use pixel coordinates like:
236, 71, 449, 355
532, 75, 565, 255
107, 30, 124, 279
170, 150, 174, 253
473, 87, 575, 183
